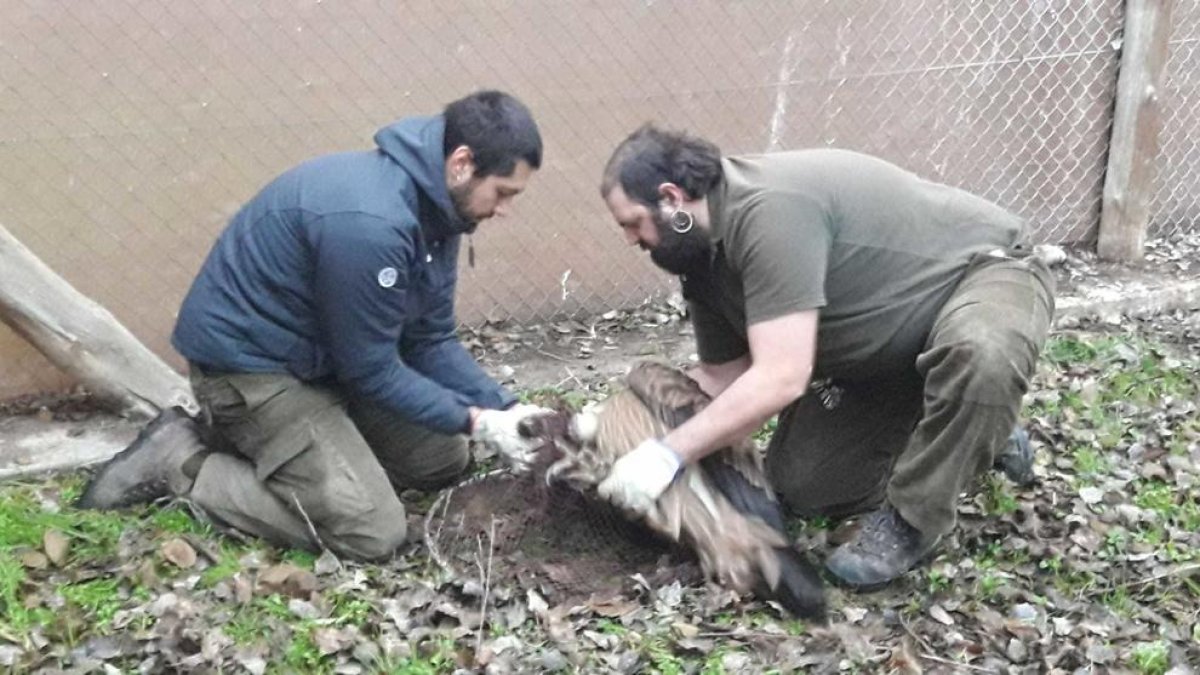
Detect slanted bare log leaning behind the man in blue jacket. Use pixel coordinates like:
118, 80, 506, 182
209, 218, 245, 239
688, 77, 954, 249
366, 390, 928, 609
0, 225, 199, 417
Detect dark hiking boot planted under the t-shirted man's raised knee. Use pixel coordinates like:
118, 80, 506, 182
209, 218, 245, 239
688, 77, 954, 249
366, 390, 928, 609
826, 503, 941, 590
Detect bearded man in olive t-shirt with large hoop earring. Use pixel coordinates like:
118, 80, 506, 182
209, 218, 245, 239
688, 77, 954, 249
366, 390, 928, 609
600, 125, 1054, 587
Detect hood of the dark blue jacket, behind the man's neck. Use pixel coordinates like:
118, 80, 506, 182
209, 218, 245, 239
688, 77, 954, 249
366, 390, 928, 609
374, 115, 472, 237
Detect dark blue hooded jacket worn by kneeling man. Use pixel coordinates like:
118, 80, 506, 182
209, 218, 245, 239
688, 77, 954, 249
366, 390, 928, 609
172, 115, 516, 434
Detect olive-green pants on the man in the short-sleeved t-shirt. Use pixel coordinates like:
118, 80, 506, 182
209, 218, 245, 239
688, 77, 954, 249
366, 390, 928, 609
767, 256, 1054, 534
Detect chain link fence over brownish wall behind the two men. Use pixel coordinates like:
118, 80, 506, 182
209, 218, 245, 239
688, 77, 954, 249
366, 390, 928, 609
0, 0, 1200, 398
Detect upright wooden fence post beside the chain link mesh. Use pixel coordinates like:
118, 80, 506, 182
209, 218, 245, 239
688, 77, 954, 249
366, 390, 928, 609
1096, 0, 1171, 261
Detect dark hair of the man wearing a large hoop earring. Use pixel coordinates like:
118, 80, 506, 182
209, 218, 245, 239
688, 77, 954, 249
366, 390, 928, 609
600, 123, 721, 208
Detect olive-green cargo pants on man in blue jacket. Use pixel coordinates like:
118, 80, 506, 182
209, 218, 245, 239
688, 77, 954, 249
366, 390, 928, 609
187, 364, 469, 560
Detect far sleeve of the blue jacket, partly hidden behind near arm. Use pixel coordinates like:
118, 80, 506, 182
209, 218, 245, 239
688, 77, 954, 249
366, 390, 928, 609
401, 247, 517, 410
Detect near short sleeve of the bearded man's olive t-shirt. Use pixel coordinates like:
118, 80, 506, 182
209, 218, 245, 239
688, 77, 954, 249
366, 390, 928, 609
725, 195, 832, 325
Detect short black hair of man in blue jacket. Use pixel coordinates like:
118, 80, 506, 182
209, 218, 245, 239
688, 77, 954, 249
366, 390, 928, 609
442, 90, 541, 178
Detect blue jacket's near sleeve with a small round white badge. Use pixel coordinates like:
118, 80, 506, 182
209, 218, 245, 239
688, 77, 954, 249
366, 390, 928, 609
311, 214, 468, 434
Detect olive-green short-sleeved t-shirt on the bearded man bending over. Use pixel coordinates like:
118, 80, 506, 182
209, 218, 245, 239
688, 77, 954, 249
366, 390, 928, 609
683, 150, 1025, 378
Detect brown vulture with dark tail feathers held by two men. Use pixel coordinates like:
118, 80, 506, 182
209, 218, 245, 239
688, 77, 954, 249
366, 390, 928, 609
521, 362, 826, 620
